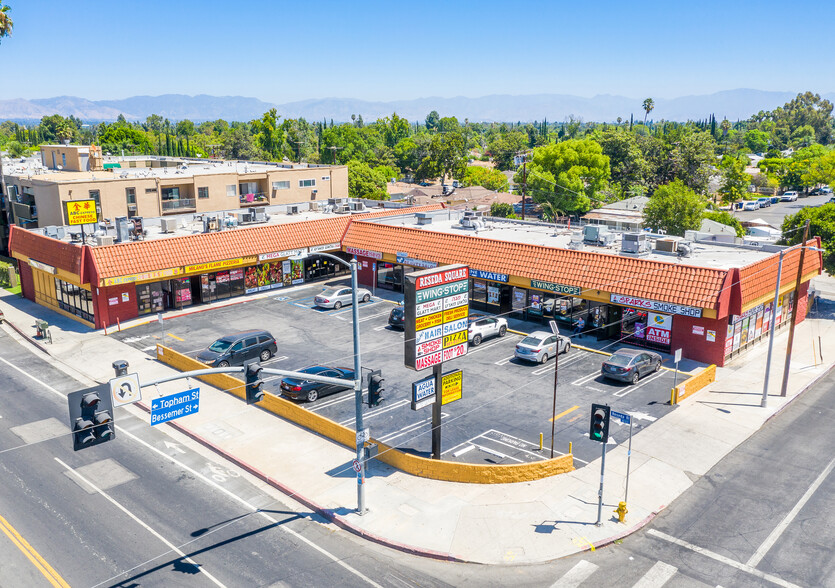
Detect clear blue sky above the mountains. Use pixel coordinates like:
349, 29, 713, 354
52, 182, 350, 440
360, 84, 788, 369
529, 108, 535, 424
0, 0, 835, 103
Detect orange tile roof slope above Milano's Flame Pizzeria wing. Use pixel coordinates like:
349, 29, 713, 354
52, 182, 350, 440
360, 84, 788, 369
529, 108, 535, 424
92, 204, 441, 278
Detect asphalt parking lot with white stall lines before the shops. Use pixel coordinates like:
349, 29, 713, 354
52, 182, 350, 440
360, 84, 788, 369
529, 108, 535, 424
113, 284, 686, 467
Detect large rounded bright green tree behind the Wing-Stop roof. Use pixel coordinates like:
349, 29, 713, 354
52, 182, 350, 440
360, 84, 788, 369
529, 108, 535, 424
513, 139, 610, 213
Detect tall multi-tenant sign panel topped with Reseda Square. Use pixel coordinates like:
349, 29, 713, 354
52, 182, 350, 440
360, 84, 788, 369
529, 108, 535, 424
404, 265, 470, 370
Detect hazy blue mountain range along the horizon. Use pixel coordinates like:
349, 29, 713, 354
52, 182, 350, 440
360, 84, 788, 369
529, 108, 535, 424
0, 89, 835, 122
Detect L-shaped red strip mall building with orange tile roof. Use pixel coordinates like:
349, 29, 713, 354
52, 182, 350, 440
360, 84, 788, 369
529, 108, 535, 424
10, 205, 822, 366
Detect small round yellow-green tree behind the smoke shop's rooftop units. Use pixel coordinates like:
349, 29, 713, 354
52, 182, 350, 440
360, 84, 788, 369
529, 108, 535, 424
644, 180, 707, 236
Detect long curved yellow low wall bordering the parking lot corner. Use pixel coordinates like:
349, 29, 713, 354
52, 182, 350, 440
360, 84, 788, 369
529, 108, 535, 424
157, 345, 574, 484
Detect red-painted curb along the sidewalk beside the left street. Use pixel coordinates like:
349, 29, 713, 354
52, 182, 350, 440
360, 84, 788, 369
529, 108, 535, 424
134, 402, 471, 563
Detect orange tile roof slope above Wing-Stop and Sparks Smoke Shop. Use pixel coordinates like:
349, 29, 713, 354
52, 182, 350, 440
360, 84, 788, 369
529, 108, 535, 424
342, 221, 728, 309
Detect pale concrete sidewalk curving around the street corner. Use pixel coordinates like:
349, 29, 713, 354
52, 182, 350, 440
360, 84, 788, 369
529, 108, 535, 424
0, 277, 835, 564
